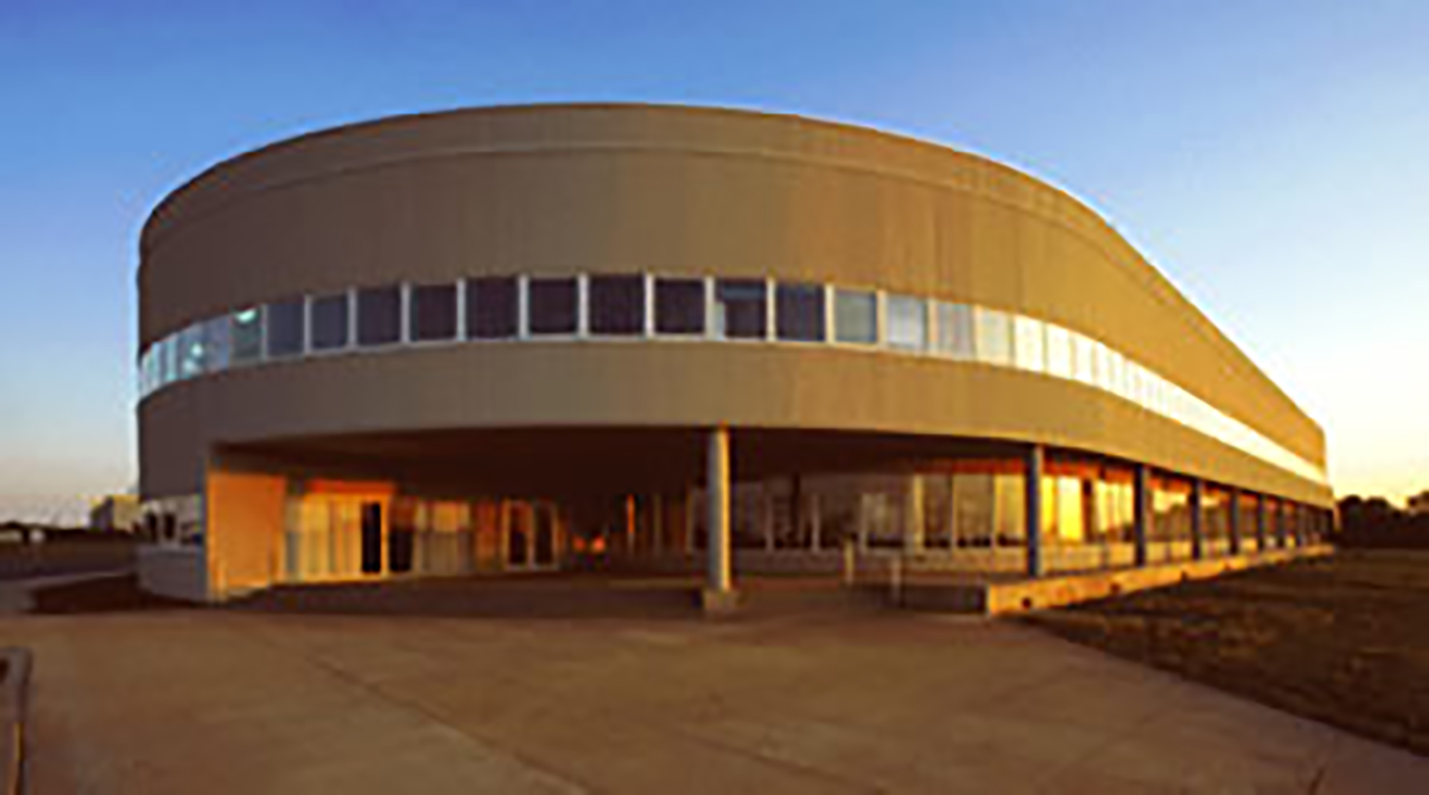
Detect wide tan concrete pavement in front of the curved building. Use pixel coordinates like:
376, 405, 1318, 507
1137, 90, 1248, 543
0, 611, 1429, 795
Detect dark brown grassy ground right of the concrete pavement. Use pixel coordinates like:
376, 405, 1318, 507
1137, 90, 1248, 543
1025, 550, 1429, 755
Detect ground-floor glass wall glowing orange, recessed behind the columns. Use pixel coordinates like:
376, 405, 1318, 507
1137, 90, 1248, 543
251, 450, 1332, 582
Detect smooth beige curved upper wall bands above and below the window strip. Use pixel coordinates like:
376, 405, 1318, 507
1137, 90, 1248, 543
140, 106, 1329, 503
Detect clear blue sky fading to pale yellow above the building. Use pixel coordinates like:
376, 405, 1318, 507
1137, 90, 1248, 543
0, 0, 1429, 518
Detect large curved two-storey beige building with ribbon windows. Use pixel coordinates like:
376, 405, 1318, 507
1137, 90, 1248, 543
139, 104, 1333, 603
